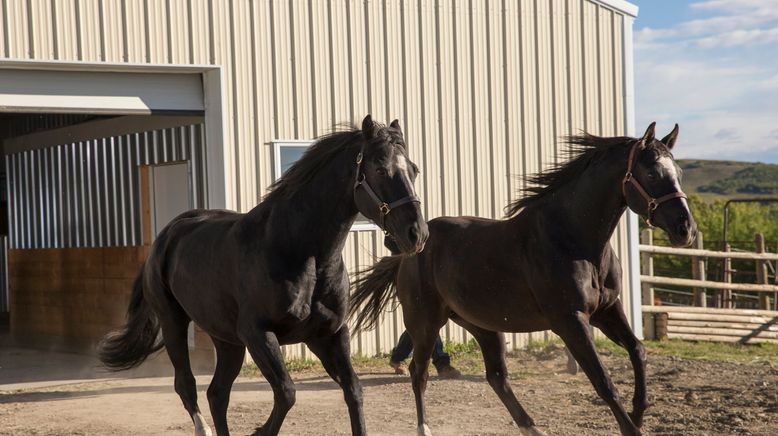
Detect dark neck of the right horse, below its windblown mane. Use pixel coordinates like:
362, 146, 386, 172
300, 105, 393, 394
554, 149, 628, 256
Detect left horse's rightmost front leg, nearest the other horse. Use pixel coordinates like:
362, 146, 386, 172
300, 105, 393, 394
305, 325, 367, 436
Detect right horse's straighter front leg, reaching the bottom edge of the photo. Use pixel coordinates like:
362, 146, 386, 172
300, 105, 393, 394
551, 312, 641, 436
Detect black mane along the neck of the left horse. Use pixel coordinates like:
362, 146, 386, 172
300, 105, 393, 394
264, 127, 363, 200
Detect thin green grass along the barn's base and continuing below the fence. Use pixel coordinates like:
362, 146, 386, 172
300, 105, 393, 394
236, 338, 778, 379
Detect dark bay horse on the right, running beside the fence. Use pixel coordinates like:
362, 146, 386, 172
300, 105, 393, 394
350, 124, 696, 435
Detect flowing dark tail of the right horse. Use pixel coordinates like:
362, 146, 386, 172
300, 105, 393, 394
349, 256, 403, 332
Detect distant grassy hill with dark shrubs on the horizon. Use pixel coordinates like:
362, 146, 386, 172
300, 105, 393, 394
677, 159, 778, 200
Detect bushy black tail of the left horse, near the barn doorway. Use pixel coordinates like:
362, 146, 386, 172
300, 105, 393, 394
98, 271, 165, 371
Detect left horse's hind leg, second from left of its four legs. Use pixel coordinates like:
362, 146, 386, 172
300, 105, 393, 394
208, 338, 246, 436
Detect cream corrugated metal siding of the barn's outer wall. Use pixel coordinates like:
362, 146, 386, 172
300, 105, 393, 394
0, 0, 629, 355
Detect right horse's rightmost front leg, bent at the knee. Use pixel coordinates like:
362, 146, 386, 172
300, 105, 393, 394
592, 301, 649, 427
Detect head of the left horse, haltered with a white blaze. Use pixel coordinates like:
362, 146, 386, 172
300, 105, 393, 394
354, 115, 429, 254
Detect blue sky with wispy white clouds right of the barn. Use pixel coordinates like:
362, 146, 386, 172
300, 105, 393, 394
631, 0, 778, 163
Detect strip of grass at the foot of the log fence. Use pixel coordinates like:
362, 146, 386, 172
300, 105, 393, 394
645, 339, 778, 365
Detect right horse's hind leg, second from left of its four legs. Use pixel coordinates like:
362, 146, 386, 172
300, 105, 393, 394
453, 318, 543, 436
